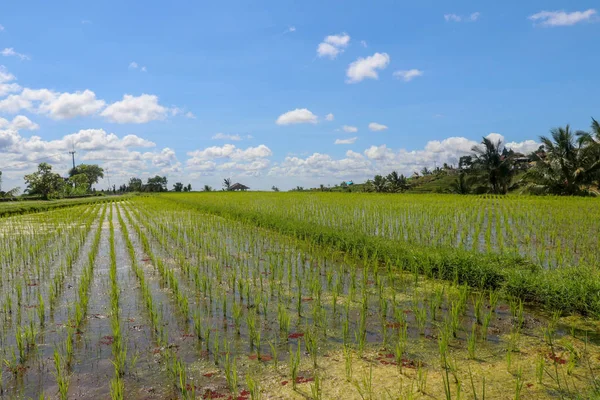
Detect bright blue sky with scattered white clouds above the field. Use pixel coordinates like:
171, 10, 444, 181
0, 0, 600, 190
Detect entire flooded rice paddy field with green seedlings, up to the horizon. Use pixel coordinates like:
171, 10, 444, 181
0, 192, 600, 399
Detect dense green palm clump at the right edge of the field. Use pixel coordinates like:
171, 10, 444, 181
525, 120, 600, 195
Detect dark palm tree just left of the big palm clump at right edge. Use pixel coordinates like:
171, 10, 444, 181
471, 137, 513, 194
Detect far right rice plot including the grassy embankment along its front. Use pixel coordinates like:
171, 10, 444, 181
162, 193, 600, 315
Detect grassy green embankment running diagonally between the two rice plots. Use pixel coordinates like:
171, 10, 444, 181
161, 194, 600, 318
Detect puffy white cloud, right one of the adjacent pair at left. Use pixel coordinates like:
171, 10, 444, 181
100, 94, 169, 124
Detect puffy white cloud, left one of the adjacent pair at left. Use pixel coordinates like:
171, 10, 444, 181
39, 90, 105, 119
